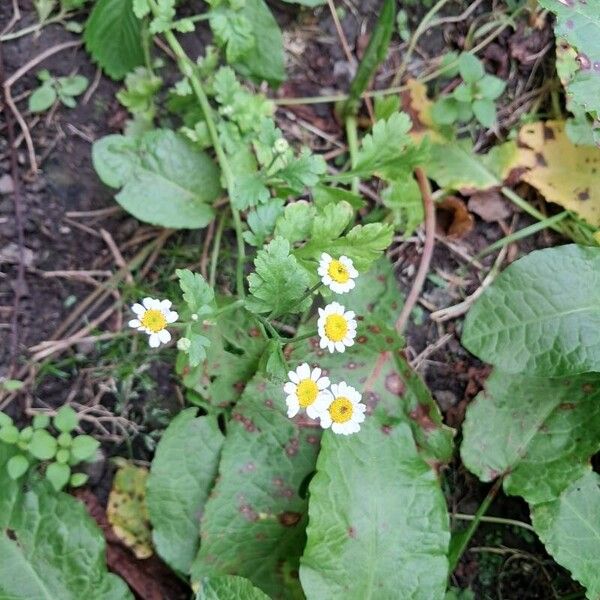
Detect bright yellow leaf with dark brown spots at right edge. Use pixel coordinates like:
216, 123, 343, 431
519, 121, 600, 227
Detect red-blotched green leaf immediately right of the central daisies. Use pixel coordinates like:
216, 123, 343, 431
293, 260, 454, 465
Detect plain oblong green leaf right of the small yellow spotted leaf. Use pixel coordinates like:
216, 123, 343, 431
146, 408, 224, 576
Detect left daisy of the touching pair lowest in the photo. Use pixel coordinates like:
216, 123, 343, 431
283, 363, 331, 419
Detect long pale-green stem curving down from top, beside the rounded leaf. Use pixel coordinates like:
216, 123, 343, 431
149, 0, 246, 298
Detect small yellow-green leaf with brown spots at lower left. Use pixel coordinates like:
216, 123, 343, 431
106, 459, 154, 558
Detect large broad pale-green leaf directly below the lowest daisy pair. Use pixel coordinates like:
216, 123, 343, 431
300, 416, 450, 600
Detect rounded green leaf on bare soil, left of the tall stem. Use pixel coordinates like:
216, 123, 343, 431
92, 129, 221, 229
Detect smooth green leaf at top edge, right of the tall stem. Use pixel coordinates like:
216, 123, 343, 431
233, 0, 285, 86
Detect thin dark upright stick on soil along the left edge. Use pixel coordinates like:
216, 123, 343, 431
0, 46, 25, 376
